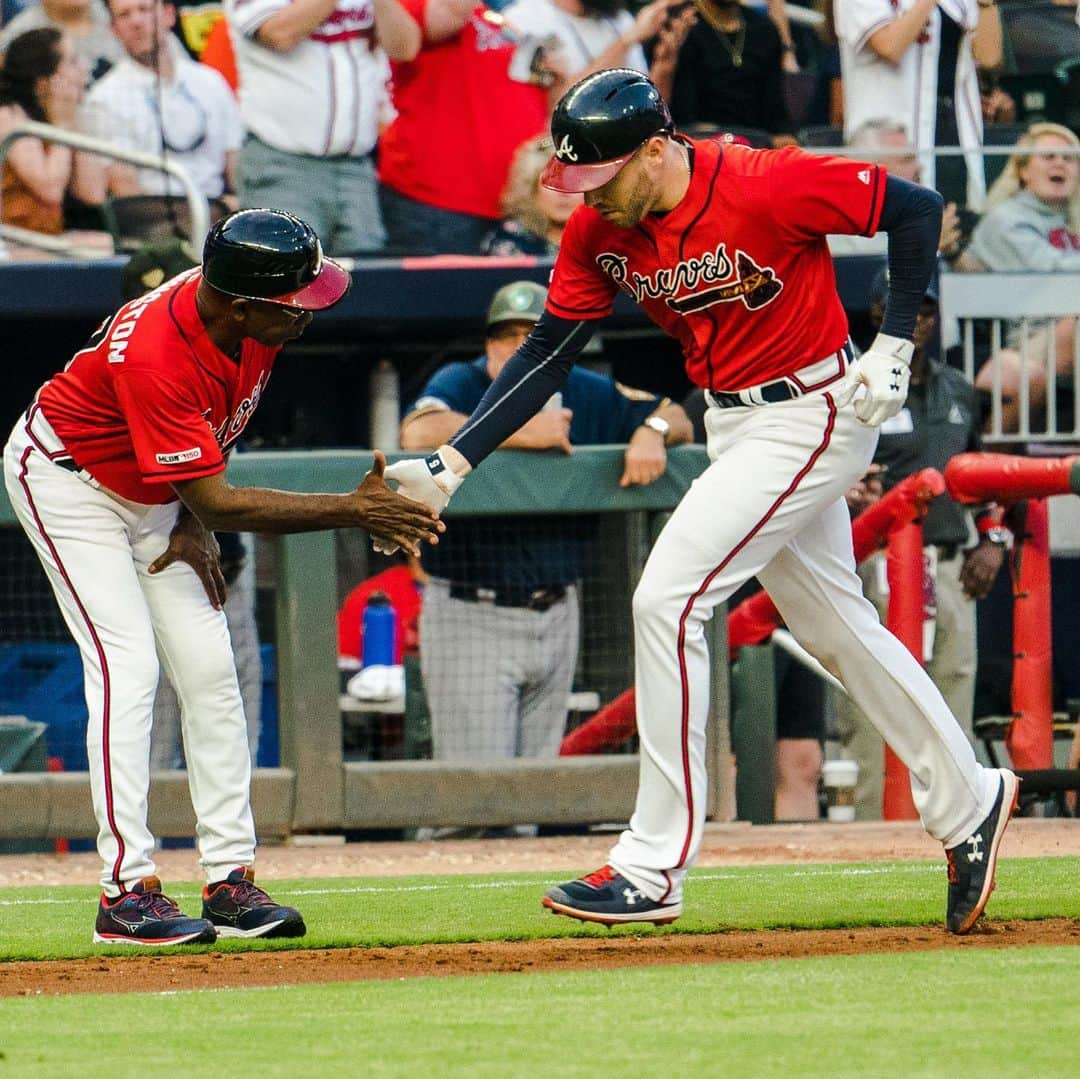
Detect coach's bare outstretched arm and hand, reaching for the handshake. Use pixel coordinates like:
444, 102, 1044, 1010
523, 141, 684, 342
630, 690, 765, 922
173, 451, 446, 555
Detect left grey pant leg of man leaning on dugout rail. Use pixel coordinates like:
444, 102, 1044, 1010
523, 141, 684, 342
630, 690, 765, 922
420, 578, 518, 763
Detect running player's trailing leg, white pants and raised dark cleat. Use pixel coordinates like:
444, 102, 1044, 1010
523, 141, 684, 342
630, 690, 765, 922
758, 499, 1017, 933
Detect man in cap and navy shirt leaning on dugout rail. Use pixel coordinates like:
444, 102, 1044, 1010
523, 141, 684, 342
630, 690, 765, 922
401, 281, 691, 781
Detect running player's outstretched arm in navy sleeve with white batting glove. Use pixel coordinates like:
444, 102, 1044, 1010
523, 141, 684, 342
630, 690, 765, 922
387, 311, 595, 513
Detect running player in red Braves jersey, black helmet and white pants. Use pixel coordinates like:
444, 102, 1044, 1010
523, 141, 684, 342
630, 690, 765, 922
387, 69, 1017, 933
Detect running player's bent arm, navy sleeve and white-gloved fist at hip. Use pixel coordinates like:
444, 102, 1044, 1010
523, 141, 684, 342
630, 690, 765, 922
837, 176, 944, 427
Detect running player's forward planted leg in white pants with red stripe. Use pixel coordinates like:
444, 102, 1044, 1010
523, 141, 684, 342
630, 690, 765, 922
548, 394, 875, 921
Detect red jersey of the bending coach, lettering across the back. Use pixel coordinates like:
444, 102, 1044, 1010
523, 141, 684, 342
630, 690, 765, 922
38, 269, 280, 504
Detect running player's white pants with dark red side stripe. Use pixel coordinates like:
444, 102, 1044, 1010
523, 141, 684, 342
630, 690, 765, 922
609, 393, 999, 902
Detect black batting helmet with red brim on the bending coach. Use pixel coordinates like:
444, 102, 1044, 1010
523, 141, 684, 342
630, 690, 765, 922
203, 210, 352, 311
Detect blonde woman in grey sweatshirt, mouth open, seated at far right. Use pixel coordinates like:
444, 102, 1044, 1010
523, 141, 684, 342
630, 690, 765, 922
959, 123, 1080, 431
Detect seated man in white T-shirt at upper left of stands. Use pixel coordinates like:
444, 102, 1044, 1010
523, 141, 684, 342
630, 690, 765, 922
82, 0, 244, 210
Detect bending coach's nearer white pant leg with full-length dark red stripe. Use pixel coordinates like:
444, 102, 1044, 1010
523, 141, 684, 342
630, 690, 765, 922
4, 435, 158, 896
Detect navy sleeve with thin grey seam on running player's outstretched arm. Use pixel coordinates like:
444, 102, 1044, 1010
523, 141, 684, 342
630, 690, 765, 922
450, 311, 596, 468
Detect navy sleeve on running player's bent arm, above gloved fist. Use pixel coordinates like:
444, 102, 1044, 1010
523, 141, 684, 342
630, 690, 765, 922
878, 176, 944, 340
